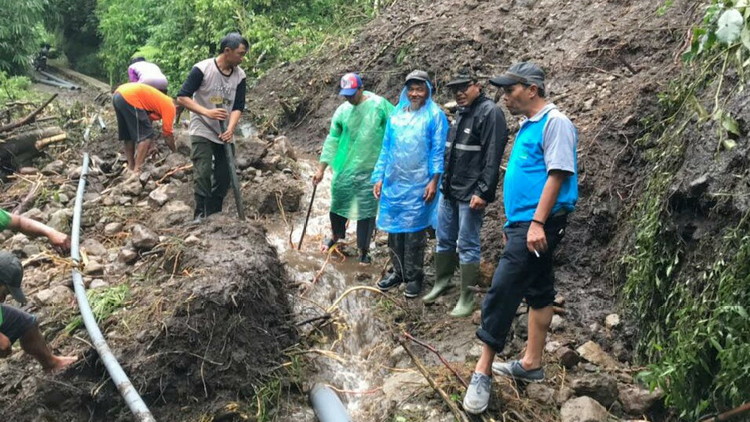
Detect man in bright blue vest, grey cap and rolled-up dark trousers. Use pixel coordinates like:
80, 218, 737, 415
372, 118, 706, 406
463, 62, 578, 414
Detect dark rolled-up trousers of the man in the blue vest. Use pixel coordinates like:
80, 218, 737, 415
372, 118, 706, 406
477, 216, 567, 353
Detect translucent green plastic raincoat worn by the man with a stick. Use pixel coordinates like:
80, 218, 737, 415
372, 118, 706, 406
320, 91, 393, 220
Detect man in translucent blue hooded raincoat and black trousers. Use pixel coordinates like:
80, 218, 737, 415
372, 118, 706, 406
371, 70, 448, 298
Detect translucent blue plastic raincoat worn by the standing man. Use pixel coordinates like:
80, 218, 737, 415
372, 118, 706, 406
371, 83, 449, 233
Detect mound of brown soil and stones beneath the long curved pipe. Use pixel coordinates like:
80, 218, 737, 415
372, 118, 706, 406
0, 99, 301, 421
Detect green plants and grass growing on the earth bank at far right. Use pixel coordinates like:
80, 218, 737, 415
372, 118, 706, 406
623, 0, 750, 419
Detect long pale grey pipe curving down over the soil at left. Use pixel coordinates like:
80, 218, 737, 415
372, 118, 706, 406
70, 154, 156, 422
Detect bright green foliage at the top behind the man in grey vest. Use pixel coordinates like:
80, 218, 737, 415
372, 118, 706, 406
97, 0, 390, 94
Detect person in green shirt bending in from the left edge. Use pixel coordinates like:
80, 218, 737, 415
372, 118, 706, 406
0, 209, 78, 372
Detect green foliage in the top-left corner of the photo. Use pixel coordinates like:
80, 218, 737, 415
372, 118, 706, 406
0, 0, 47, 75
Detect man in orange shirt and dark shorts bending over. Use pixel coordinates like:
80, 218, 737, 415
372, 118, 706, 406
112, 83, 175, 173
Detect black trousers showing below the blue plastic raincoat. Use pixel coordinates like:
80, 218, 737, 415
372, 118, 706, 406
388, 230, 426, 283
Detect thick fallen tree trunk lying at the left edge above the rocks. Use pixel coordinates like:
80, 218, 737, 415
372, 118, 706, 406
0, 126, 67, 169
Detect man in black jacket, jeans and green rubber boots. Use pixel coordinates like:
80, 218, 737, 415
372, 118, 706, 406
423, 72, 508, 317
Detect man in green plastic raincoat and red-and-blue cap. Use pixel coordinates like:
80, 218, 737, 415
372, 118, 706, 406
313, 73, 393, 264
